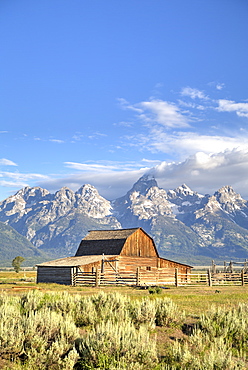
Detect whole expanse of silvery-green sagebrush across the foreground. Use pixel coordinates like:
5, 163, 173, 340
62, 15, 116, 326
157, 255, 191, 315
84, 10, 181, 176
0, 291, 248, 370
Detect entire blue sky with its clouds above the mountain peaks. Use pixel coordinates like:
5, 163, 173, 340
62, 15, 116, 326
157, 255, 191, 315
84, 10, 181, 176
0, 0, 248, 200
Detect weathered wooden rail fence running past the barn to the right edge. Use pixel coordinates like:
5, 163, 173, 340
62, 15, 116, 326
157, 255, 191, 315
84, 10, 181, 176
71, 268, 248, 286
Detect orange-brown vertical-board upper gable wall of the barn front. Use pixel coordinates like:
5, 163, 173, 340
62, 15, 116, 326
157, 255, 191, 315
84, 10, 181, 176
120, 229, 158, 257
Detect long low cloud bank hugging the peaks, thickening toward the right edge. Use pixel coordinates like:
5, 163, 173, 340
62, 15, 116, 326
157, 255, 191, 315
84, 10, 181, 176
36, 148, 248, 200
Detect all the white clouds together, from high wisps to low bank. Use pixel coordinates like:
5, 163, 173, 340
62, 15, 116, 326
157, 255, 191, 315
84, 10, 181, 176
0, 88, 248, 199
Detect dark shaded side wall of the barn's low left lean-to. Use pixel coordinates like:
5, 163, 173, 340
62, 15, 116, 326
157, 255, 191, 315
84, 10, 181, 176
37, 266, 73, 285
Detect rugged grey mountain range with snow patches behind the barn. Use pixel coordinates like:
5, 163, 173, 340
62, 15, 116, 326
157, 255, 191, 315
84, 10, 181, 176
0, 175, 248, 263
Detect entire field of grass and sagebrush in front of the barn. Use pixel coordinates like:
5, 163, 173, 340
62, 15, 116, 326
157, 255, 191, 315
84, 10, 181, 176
0, 271, 248, 370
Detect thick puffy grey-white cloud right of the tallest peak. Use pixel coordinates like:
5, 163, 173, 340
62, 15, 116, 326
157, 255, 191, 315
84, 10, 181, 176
148, 149, 248, 198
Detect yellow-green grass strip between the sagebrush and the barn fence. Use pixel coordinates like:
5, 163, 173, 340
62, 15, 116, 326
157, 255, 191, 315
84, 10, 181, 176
0, 271, 248, 316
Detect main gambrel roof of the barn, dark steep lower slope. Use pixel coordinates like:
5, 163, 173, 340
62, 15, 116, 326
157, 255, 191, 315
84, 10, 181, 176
76, 228, 139, 256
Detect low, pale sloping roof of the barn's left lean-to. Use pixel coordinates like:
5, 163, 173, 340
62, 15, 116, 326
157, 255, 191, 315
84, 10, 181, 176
36, 255, 116, 267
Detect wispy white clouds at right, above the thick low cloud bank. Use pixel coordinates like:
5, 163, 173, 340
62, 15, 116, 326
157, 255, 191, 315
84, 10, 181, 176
117, 91, 248, 160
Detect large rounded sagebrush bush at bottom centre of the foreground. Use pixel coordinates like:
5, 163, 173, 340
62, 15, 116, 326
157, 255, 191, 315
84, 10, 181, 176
76, 321, 158, 369
